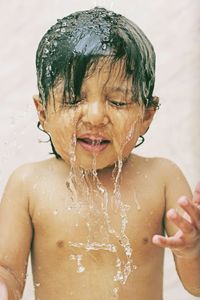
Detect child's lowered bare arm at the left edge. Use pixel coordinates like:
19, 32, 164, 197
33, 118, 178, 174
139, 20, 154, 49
0, 167, 32, 300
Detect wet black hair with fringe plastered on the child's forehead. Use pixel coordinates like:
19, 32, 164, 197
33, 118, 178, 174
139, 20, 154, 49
36, 7, 156, 107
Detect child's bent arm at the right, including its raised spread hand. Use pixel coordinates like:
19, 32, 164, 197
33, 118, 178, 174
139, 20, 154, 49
153, 166, 200, 296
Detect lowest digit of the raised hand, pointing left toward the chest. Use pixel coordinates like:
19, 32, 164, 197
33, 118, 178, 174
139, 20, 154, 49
152, 235, 184, 249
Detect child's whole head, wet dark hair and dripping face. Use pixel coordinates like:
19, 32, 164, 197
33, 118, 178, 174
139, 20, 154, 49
35, 7, 157, 169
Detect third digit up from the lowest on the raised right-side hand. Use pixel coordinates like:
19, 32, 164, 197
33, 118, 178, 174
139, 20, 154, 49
178, 197, 200, 230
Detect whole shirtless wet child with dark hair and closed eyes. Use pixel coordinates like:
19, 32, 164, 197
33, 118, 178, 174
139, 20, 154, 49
0, 8, 200, 300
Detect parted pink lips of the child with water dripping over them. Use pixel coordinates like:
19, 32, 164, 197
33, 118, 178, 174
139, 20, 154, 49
77, 134, 111, 153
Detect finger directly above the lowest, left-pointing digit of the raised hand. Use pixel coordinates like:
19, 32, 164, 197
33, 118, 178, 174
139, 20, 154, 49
167, 208, 195, 234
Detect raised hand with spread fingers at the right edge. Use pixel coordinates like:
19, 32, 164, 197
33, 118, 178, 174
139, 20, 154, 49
152, 182, 200, 258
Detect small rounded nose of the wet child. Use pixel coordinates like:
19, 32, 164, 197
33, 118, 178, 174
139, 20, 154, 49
83, 100, 108, 126
